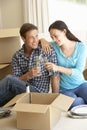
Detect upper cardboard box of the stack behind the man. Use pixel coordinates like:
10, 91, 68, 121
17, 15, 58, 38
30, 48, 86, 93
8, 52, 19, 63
0, 28, 21, 63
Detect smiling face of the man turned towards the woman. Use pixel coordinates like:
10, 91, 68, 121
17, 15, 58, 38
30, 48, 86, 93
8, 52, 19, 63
23, 30, 39, 50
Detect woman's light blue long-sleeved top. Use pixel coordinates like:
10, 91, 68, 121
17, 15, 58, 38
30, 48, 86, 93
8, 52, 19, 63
51, 42, 87, 90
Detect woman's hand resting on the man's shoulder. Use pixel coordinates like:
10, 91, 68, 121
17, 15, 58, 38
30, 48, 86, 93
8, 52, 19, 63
40, 38, 51, 54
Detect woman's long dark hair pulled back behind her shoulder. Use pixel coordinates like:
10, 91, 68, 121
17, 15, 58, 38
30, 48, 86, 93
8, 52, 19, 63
48, 20, 81, 42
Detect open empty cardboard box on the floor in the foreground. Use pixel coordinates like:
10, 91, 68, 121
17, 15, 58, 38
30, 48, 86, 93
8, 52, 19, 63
5, 93, 74, 130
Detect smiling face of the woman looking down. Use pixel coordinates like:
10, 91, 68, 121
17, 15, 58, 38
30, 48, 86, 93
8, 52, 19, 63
50, 29, 66, 46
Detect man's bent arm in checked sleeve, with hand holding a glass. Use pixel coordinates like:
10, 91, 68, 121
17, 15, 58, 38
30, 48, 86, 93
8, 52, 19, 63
12, 54, 40, 81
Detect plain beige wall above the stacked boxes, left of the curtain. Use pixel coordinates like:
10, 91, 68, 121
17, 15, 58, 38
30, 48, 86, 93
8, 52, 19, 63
0, 0, 24, 28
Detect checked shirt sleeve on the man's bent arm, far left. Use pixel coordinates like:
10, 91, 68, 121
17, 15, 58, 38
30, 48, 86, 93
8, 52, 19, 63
12, 54, 22, 77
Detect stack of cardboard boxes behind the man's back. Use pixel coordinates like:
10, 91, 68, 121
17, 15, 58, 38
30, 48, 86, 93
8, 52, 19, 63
0, 28, 21, 79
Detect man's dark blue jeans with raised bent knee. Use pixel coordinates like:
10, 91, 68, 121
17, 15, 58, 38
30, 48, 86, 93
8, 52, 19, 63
0, 75, 37, 107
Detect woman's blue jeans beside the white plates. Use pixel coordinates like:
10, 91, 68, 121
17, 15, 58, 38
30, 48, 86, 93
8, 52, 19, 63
60, 82, 87, 109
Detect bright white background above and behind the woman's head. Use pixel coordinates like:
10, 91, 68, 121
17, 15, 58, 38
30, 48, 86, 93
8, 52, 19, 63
49, 0, 87, 43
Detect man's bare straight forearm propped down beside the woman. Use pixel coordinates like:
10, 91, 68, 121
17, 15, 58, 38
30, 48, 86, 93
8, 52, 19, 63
51, 75, 60, 93
